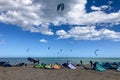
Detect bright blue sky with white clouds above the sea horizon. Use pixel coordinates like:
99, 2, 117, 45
0, 0, 120, 57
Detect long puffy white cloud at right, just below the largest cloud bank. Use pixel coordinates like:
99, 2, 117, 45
56, 26, 120, 41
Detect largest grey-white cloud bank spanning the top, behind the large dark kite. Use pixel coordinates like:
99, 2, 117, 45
0, 0, 120, 27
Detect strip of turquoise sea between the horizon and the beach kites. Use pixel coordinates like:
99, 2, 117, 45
0, 57, 120, 64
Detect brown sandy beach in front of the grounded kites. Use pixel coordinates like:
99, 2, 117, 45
0, 65, 120, 80
